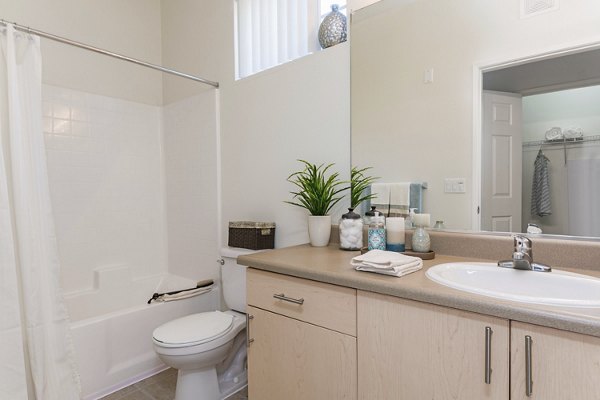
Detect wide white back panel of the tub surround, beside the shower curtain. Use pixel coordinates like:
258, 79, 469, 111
43, 85, 167, 292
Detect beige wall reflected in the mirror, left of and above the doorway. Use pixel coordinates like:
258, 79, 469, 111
352, 0, 600, 229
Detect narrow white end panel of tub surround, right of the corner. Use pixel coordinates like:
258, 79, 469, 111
163, 90, 219, 280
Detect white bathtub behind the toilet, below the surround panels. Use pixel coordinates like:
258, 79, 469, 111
65, 267, 220, 400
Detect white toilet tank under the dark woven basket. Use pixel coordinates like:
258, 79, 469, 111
221, 247, 256, 313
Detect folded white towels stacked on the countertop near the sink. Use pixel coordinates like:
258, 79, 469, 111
350, 250, 423, 277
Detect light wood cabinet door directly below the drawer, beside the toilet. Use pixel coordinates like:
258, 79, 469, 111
247, 306, 357, 400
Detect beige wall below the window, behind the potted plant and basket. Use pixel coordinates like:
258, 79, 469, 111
221, 44, 350, 247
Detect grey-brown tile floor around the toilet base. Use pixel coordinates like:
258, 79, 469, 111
102, 368, 248, 400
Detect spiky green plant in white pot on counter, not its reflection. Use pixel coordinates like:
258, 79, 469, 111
286, 160, 348, 247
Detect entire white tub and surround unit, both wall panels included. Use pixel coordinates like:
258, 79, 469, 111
41, 85, 219, 399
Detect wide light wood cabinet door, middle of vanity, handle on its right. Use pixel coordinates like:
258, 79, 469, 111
357, 291, 509, 400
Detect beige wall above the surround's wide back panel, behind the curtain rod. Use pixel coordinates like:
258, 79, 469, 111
0, 0, 162, 105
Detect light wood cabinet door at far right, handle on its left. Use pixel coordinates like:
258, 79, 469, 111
510, 322, 600, 400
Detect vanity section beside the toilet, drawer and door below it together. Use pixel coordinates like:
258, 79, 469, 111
247, 269, 357, 400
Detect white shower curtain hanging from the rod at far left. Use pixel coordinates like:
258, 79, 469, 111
0, 24, 80, 400
